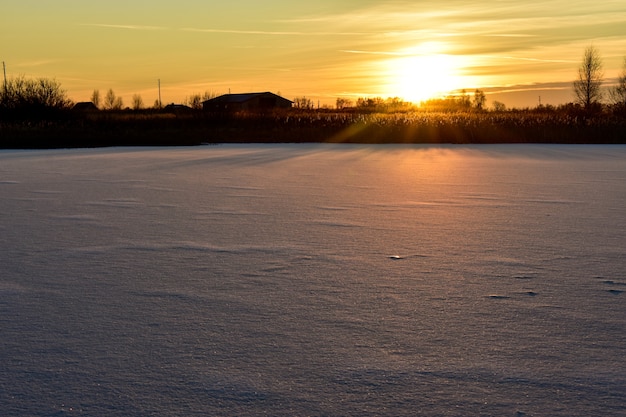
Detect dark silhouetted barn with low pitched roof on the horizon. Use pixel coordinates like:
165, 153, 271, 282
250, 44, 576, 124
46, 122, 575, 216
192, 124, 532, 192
202, 92, 293, 112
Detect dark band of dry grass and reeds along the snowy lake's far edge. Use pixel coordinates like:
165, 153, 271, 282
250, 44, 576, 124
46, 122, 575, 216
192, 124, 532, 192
0, 110, 626, 148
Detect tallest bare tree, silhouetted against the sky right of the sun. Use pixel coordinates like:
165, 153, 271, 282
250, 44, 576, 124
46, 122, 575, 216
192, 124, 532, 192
574, 45, 604, 110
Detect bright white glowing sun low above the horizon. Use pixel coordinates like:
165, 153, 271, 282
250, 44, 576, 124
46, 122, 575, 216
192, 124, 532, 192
386, 54, 463, 103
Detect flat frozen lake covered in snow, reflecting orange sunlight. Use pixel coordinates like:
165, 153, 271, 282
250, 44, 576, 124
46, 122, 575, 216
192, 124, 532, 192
0, 144, 626, 417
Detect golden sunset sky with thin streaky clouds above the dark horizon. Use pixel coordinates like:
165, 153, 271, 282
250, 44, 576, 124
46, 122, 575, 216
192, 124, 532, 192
0, 0, 626, 107
